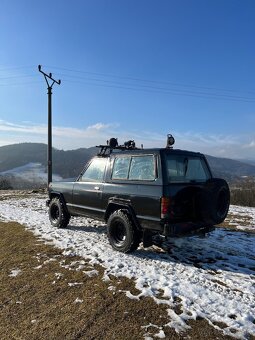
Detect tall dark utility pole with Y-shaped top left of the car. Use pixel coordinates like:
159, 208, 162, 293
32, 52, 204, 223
38, 65, 61, 186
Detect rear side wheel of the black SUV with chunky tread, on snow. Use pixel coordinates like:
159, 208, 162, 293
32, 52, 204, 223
107, 210, 141, 253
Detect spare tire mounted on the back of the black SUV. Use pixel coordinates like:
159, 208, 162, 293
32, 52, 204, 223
198, 178, 230, 224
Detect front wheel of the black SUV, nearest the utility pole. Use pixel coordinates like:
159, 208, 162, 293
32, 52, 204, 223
49, 197, 70, 228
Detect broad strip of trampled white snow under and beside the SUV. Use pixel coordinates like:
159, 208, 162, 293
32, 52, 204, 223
0, 195, 255, 339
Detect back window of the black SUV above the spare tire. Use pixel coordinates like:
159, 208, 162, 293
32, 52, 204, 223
166, 154, 211, 183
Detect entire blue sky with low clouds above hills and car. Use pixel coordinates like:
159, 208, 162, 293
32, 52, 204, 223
0, 0, 255, 159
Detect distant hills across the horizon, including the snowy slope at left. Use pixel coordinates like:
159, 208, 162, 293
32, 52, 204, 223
0, 143, 255, 189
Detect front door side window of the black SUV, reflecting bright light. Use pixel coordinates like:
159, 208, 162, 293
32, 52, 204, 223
80, 158, 107, 182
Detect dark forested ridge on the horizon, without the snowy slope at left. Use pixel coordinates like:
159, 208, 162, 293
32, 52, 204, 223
0, 143, 255, 187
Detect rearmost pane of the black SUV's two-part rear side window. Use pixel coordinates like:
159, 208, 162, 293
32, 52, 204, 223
129, 155, 156, 181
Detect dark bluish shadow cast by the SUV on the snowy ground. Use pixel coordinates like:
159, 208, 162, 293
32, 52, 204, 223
66, 224, 255, 275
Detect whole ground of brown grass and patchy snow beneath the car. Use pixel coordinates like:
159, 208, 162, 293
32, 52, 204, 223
0, 191, 255, 339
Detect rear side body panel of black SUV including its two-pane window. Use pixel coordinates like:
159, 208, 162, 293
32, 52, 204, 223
104, 154, 162, 227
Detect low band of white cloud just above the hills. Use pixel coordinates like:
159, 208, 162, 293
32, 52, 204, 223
0, 120, 255, 159
